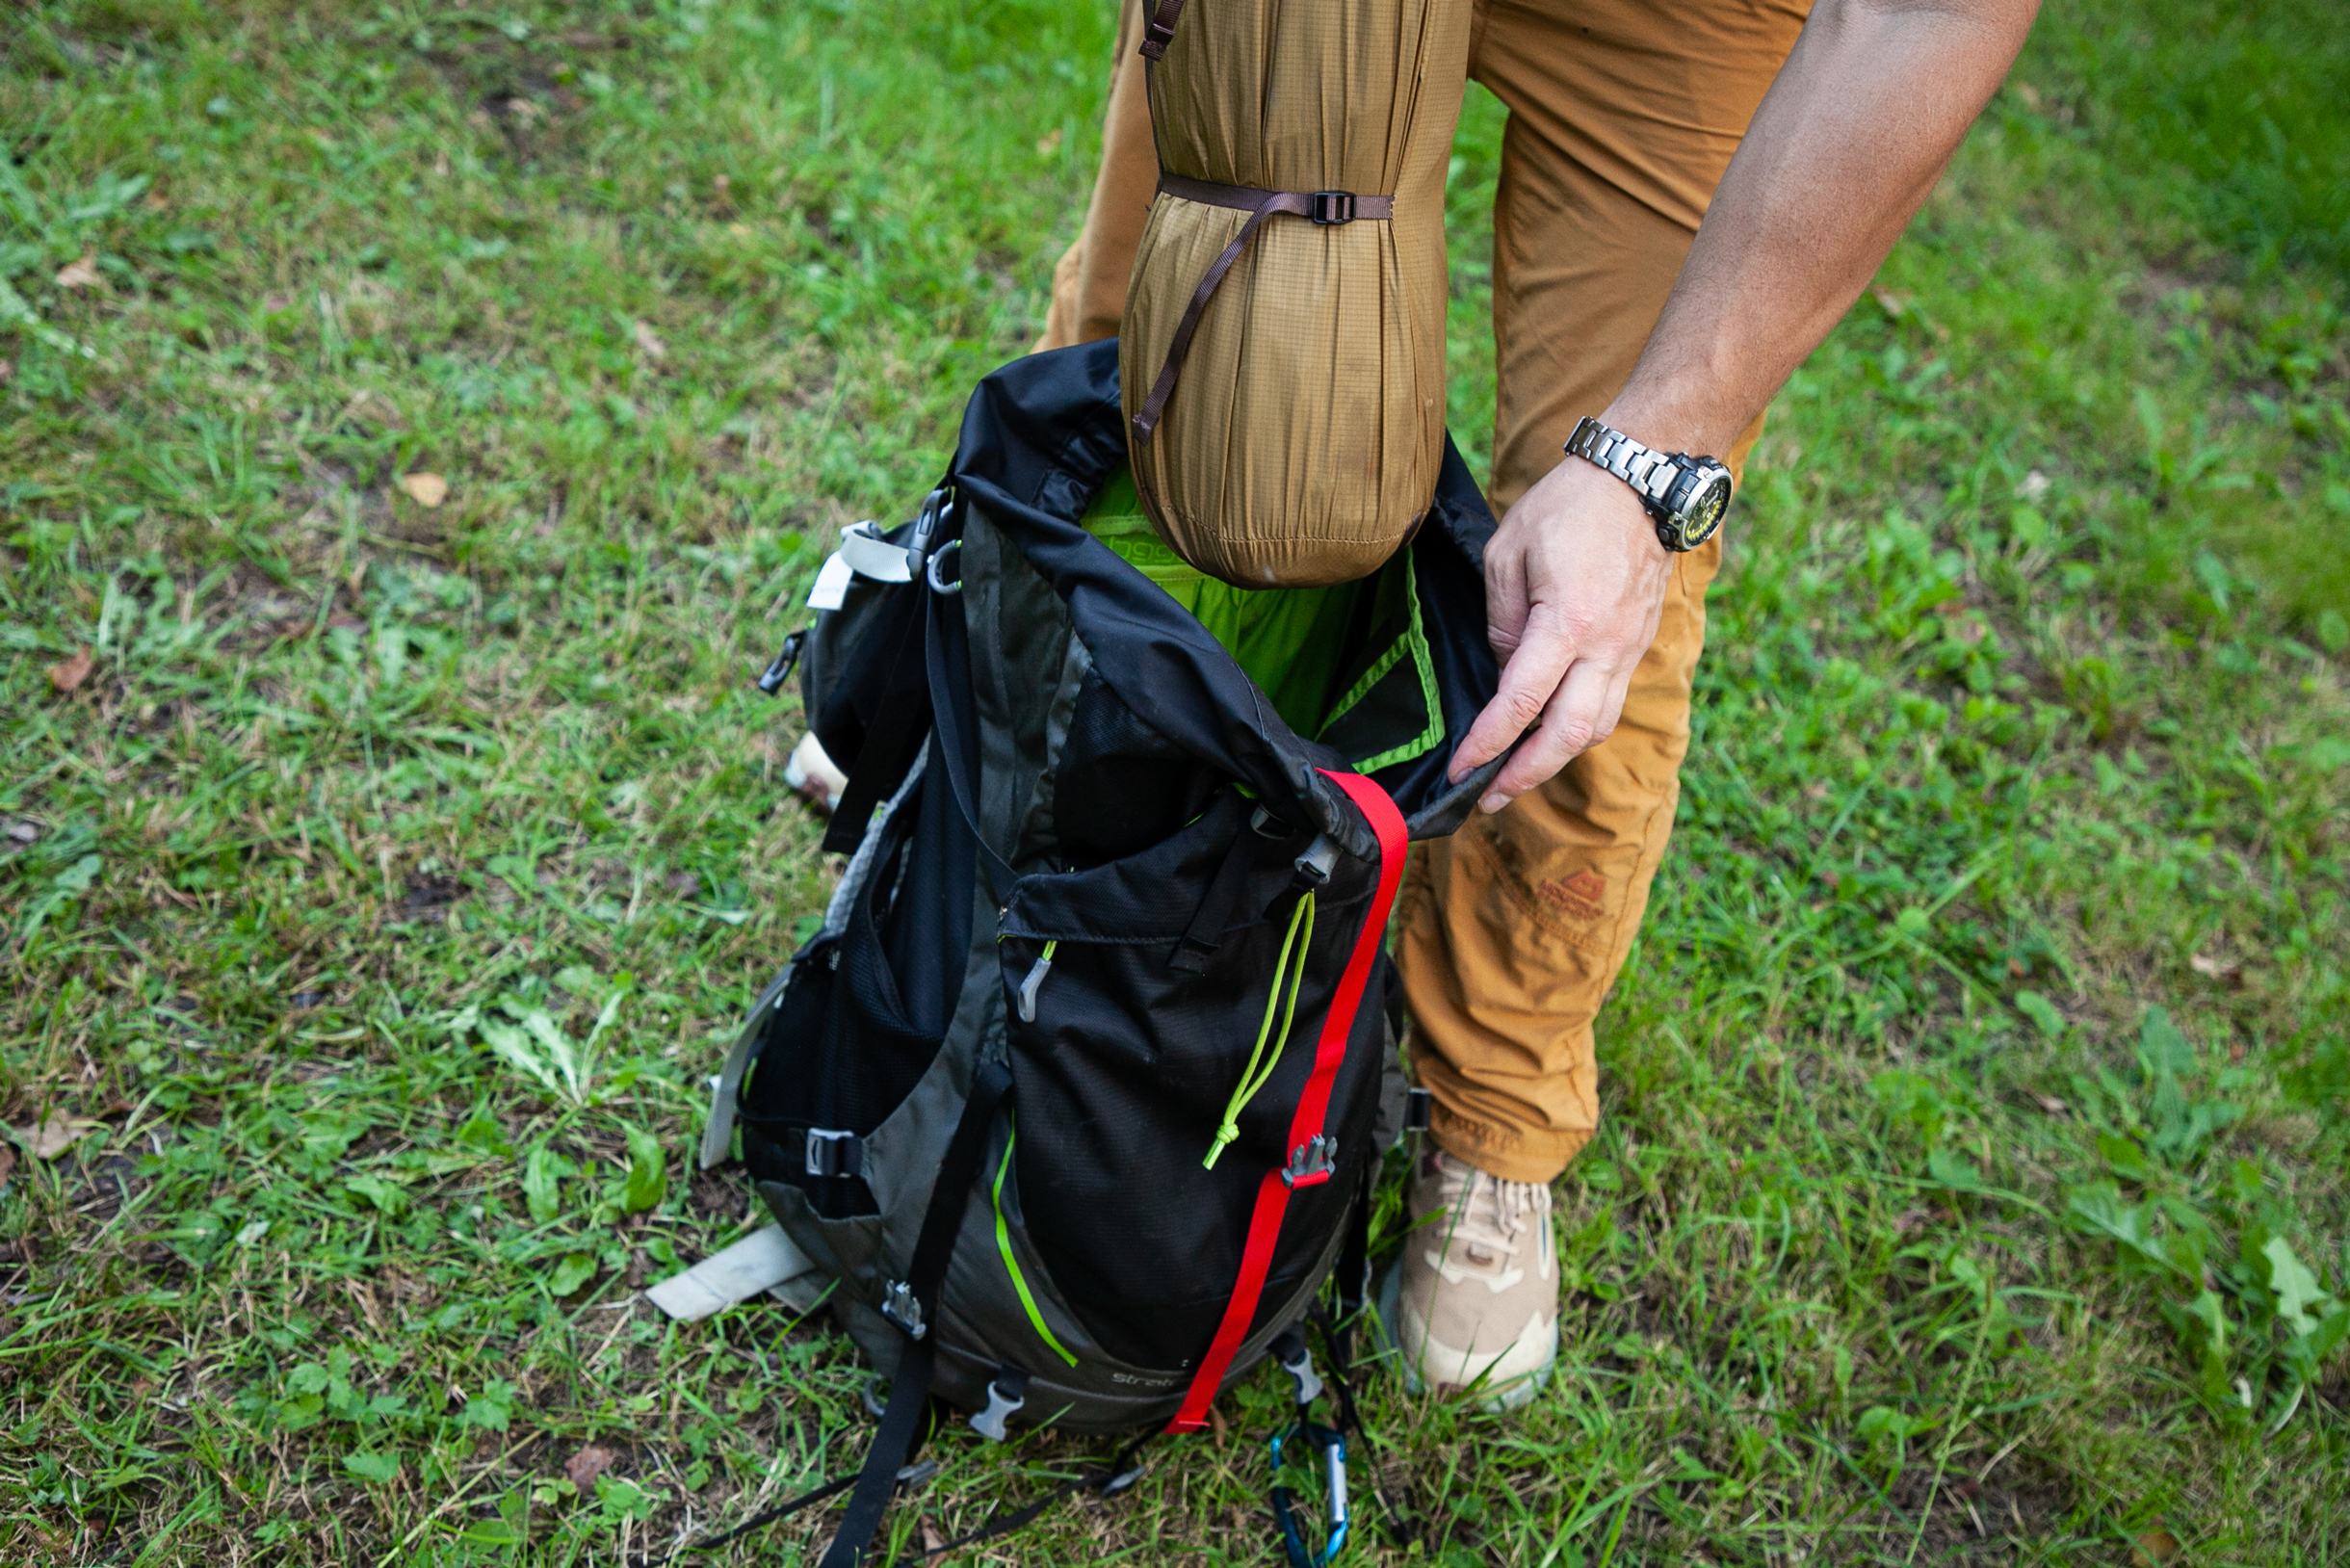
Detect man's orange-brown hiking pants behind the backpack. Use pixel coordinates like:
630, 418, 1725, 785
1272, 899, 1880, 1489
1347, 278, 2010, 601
1038, 0, 1810, 1183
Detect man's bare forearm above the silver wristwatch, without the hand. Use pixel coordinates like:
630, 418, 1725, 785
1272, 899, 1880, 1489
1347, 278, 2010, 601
1603, 0, 2037, 454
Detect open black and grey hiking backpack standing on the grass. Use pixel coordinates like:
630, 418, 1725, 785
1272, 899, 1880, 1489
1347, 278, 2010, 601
703, 343, 1495, 1568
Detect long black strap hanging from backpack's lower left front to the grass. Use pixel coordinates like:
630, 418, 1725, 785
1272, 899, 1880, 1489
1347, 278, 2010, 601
821, 1062, 1013, 1568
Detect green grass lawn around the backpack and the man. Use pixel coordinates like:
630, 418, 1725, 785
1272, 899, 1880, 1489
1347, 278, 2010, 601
0, 0, 2350, 1568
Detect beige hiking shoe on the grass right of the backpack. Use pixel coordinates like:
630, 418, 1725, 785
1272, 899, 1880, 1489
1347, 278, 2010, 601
1379, 1147, 1558, 1410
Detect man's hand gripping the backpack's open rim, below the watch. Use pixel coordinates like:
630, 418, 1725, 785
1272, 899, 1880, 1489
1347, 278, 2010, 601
1452, 441, 1673, 811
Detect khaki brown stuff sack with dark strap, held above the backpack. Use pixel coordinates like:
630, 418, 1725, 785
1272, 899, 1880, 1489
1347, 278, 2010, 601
1118, 0, 1471, 588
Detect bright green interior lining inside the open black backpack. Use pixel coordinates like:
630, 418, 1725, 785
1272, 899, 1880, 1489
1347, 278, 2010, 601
1081, 468, 1446, 773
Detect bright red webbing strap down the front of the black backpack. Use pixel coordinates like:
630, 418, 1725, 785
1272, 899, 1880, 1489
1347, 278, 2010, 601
1168, 769, 1405, 1431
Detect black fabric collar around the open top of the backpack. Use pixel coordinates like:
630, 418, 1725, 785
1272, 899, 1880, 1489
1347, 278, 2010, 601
947, 338, 1500, 858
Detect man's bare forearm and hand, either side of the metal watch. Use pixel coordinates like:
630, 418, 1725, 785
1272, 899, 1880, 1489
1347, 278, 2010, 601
1452, 0, 2037, 811
